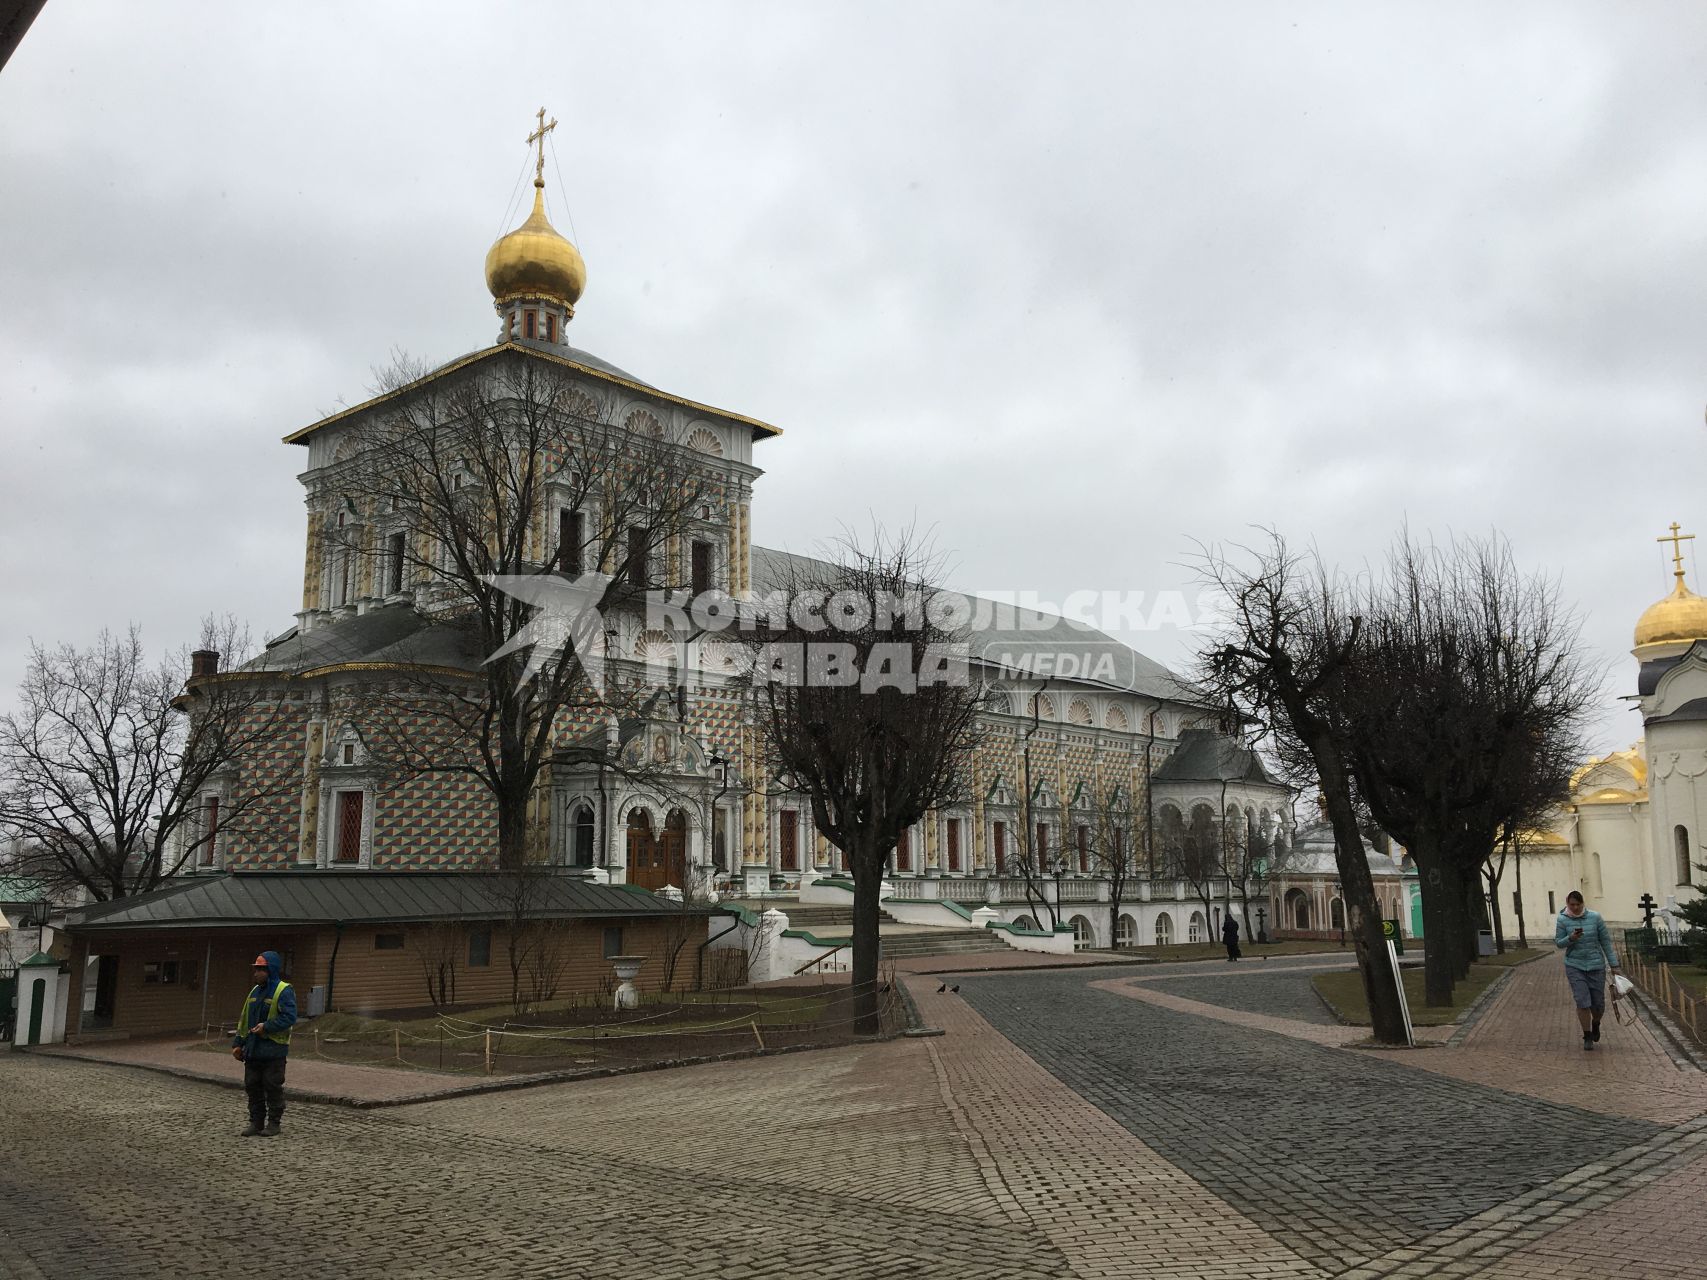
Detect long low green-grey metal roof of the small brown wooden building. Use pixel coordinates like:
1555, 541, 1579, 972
67, 870, 707, 934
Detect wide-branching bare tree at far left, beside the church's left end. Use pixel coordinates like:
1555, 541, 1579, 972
0, 618, 300, 901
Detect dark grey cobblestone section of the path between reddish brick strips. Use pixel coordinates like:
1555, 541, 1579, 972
961, 975, 1656, 1270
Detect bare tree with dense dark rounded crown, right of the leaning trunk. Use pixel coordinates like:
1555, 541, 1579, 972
1338, 534, 1601, 1005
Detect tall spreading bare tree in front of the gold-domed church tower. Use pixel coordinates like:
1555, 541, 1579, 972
324, 350, 725, 869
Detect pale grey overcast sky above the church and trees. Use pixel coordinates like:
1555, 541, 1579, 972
0, 0, 1707, 749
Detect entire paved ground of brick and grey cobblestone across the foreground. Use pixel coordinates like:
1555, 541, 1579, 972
0, 959, 1707, 1280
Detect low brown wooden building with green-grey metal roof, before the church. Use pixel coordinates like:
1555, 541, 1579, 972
67, 869, 708, 1038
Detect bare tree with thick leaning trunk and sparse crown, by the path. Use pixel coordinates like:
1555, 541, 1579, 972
1200, 532, 1405, 1044
